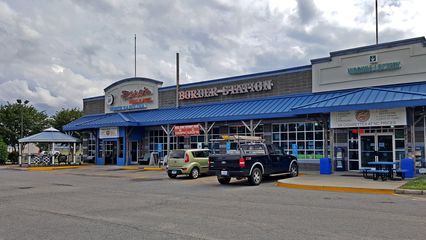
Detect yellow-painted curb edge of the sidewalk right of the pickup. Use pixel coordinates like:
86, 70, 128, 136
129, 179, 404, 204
275, 182, 395, 195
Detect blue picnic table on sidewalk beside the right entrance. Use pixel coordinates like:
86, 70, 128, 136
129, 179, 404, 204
362, 161, 406, 181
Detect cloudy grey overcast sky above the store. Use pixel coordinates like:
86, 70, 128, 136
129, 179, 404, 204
0, 0, 426, 114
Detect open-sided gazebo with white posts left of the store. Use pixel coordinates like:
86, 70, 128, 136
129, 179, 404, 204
18, 127, 81, 165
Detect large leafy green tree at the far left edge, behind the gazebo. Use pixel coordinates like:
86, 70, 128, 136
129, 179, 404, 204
0, 102, 48, 151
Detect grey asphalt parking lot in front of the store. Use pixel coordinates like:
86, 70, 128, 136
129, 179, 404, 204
0, 166, 426, 239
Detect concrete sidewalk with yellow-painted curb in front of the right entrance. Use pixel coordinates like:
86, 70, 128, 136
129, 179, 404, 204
277, 172, 407, 194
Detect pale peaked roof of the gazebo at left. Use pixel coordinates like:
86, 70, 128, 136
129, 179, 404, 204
18, 128, 80, 143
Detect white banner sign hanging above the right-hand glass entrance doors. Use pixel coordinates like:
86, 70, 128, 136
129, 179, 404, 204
330, 108, 407, 128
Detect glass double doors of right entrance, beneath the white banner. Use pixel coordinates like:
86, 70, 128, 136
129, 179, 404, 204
359, 133, 395, 167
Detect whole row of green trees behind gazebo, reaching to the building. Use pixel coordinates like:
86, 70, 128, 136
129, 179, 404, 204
0, 102, 83, 163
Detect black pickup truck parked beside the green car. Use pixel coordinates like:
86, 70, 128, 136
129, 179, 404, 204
209, 143, 299, 185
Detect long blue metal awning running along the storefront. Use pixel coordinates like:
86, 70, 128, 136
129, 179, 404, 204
64, 82, 426, 131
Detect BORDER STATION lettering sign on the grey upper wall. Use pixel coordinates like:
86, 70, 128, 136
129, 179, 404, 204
179, 80, 274, 100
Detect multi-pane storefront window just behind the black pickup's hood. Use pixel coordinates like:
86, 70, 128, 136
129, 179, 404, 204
272, 122, 324, 159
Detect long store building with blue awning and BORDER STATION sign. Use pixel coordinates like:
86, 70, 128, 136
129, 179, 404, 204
64, 37, 426, 171
